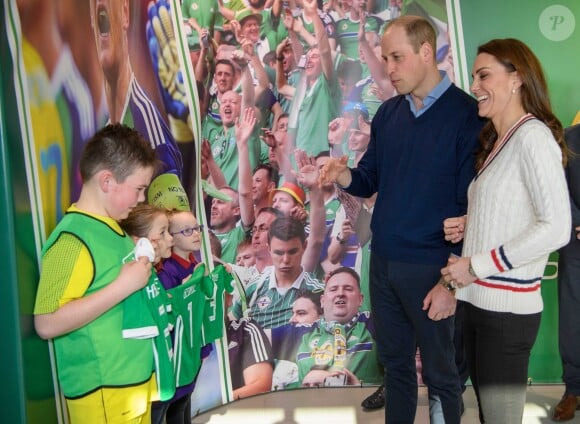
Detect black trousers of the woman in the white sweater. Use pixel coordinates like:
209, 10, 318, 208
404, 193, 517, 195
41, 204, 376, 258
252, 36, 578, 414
463, 303, 541, 424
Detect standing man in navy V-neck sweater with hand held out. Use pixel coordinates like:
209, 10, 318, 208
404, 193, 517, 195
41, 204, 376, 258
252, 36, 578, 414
321, 15, 483, 424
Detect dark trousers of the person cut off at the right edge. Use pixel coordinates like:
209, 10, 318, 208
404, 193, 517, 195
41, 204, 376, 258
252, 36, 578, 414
558, 240, 580, 396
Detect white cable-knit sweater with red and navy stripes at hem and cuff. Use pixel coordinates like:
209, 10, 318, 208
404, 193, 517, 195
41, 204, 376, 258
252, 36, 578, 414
457, 115, 571, 314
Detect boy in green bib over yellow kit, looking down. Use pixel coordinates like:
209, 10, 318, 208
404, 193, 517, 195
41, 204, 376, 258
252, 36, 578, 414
34, 124, 158, 424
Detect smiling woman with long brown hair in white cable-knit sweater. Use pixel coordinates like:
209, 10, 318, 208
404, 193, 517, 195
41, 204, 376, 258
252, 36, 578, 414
441, 39, 571, 424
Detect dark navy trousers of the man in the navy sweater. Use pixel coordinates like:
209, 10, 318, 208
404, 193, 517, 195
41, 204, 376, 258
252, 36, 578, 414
370, 253, 461, 424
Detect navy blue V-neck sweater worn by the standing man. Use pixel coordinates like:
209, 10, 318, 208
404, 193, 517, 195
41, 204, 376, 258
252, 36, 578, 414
346, 85, 484, 264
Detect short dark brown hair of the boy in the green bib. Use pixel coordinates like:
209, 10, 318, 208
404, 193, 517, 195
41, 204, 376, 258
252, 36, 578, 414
79, 124, 159, 183
